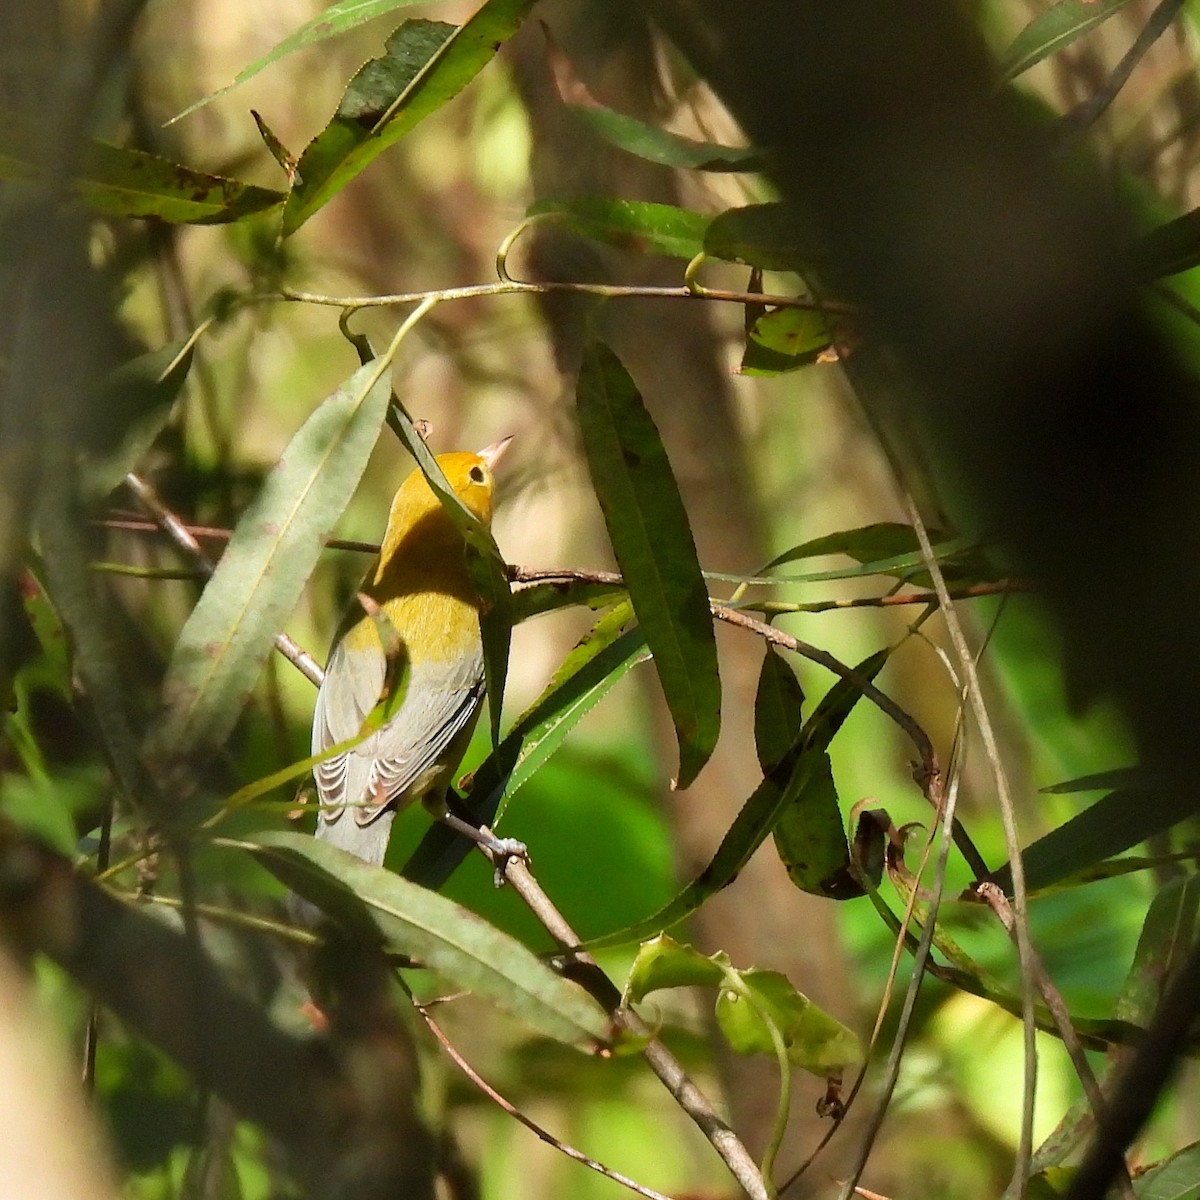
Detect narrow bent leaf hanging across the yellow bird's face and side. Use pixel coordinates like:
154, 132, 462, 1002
388, 401, 514, 746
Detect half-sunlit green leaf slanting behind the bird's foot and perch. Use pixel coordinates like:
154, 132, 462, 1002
404, 601, 649, 887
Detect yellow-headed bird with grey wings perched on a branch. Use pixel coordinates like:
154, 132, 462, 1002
312, 438, 523, 865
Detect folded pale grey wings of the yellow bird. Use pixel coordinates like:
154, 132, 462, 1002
312, 643, 484, 824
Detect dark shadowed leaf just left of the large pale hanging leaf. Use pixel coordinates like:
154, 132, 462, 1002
83, 342, 192, 498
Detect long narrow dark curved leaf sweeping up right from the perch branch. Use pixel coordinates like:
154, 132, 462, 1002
587, 649, 890, 949
